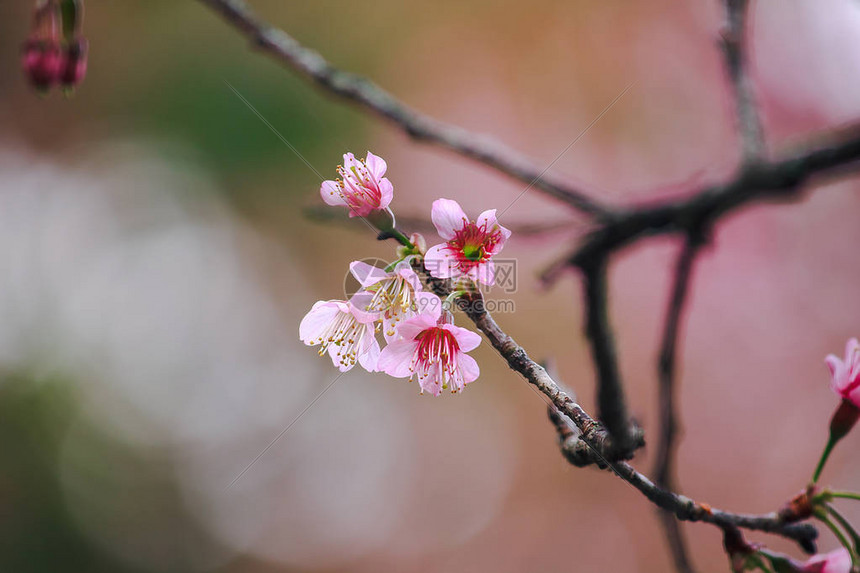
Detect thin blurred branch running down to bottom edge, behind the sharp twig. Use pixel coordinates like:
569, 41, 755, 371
653, 237, 701, 573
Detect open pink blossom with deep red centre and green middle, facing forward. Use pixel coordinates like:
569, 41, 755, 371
424, 199, 511, 285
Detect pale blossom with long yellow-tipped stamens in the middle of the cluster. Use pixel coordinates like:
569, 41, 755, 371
349, 257, 439, 342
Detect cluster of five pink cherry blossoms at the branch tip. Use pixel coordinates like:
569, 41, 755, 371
299, 151, 511, 396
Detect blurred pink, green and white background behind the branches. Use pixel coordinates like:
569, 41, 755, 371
0, 0, 860, 573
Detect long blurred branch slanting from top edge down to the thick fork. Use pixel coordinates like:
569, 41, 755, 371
200, 0, 608, 215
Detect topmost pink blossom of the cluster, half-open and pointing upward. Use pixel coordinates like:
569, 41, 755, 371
320, 151, 394, 217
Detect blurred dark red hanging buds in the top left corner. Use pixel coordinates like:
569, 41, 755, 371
21, 0, 89, 92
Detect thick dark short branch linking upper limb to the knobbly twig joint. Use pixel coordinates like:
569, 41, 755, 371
582, 258, 636, 457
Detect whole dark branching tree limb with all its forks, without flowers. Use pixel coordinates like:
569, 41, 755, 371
200, 0, 860, 571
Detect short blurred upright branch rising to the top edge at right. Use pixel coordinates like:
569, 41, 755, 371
722, 0, 764, 163
